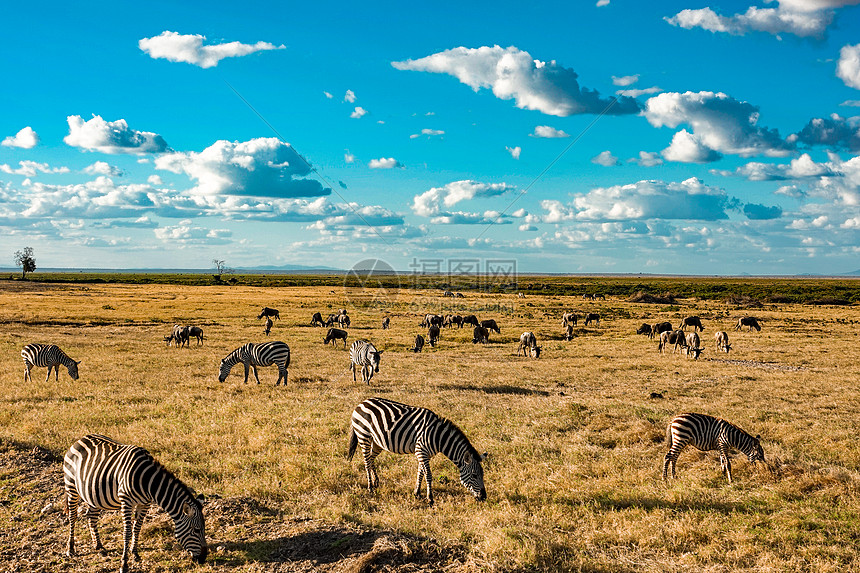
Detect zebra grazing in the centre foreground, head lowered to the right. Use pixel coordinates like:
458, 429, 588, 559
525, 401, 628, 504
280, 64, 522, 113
347, 398, 487, 505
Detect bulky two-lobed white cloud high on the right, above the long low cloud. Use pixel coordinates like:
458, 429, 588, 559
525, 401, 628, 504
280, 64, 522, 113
644, 92, 794, 163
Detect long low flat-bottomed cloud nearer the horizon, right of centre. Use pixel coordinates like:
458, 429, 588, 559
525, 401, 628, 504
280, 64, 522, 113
541, 178, 736, 223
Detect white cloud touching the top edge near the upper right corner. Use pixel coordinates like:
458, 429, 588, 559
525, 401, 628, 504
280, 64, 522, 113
666, 0, 860, 38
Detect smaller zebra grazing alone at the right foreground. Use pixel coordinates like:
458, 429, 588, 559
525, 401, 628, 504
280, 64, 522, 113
663, 414, 764, 483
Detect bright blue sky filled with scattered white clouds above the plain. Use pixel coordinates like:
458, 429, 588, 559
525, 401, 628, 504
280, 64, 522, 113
0, 0, 860, 274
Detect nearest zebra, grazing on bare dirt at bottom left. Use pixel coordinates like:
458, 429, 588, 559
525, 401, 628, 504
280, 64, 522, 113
63, 434, 209, 573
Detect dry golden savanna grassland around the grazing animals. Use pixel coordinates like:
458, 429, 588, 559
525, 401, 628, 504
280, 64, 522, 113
0, 279, 860, 573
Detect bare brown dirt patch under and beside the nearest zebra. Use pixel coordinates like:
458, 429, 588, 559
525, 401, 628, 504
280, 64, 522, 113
0, 440, 470, 573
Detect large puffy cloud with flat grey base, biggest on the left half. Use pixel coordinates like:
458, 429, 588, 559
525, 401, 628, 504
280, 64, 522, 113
155, 137, 331, 197
